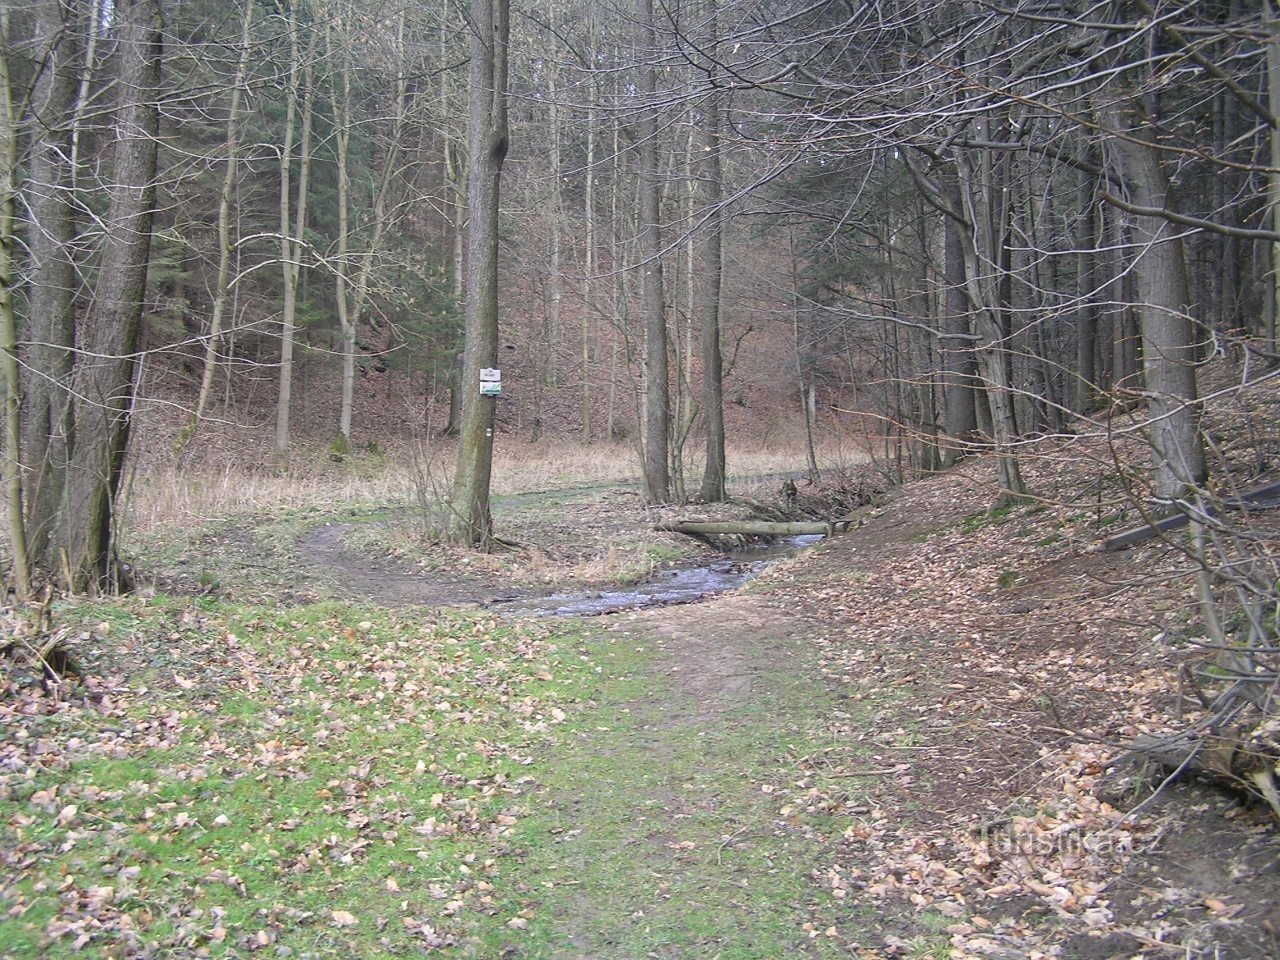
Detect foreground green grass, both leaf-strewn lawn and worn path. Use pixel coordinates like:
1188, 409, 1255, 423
0, 586, 921, 960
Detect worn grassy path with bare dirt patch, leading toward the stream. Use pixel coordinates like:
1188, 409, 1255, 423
494, 596, 875, 960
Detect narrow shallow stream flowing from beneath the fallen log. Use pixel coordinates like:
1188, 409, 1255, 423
485, 535, 822, 617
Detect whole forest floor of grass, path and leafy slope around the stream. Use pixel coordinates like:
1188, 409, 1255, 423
0, 444, 1280, 960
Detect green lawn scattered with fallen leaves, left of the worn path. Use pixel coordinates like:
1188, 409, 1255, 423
0, 600, 586, 957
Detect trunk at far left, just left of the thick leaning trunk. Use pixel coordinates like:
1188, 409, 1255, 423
23, 0, 83, 563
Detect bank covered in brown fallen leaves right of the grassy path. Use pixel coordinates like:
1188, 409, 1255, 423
747, 417, 1280, 959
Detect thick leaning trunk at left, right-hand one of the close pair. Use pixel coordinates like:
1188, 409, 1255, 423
55, 0, 163, 590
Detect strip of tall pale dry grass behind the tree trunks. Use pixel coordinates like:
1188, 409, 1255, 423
124, 438, 865, 530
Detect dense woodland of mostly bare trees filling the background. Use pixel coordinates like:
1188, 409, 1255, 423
4, 3, 1280, 589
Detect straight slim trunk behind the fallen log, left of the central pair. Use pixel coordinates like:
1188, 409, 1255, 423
636, 0, 671, 503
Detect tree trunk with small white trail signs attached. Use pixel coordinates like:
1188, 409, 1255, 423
451, 0, 509, 548
